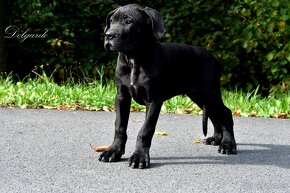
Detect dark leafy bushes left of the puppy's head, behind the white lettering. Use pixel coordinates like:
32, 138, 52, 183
5, 0, 114, 81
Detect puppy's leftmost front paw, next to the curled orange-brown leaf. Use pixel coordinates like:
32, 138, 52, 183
99, 146, 125, 162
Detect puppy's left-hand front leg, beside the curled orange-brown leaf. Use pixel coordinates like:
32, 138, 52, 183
99, 86, 131, 162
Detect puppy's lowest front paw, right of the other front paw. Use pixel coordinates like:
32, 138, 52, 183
128, 149, 150, 169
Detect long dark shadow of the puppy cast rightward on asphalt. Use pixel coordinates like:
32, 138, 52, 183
151, 144, 290, 169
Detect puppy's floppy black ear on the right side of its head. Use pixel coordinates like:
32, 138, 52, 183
144, 7, 166, 40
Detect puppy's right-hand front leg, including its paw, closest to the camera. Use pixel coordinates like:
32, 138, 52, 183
128, 100, 163, 169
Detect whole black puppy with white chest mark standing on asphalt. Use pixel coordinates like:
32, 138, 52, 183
99, 4, 236, 168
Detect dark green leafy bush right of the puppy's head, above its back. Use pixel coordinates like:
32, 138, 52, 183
161, 0, 290, 90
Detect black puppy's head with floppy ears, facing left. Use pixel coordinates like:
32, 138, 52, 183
104, 4, 165, 53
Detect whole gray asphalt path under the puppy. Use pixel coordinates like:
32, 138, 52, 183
0, 109, 290, 193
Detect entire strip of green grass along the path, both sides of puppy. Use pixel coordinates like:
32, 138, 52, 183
0, 75, 290, 118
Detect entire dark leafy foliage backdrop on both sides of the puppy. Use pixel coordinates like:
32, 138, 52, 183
0, 0, 290, 94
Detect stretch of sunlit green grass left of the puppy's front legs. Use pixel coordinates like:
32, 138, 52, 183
0, 73, 115, 110
